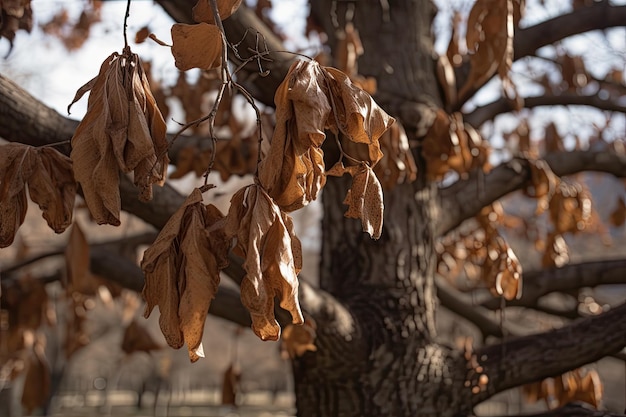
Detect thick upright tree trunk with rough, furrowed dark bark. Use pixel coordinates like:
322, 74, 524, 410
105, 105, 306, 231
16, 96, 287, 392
294, 0, 471, 417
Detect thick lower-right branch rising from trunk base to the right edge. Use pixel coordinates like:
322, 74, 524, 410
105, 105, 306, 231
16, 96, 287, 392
468, 304, 626, 404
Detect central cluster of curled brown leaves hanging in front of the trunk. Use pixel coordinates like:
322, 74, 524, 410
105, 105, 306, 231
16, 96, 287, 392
142, 56, 393, 361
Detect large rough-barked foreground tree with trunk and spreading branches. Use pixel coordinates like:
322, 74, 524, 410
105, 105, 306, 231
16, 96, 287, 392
0, 0, 626, 416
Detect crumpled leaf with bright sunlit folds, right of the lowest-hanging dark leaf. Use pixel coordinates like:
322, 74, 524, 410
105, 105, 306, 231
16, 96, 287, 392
224, 185, 304, 340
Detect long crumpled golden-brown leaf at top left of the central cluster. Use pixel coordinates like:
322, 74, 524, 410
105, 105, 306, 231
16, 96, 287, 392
259, 61, 331, 211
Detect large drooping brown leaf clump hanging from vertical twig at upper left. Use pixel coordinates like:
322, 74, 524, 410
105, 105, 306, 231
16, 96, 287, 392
68, 48, 169, 226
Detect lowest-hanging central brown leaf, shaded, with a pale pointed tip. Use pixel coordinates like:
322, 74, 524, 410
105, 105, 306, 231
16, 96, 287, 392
141, 189, 230, 362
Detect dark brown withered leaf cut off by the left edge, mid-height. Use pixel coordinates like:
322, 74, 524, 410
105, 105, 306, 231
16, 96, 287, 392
0, 143, 76, 247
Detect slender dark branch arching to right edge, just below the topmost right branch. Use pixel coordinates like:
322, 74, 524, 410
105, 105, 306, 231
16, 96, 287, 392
463, 91, 626, 127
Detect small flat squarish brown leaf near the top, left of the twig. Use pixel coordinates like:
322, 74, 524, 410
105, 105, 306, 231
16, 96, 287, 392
171, 23, 222, 71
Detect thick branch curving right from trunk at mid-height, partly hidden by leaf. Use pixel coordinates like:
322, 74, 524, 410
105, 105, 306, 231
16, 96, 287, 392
437, 151, 626, 236
